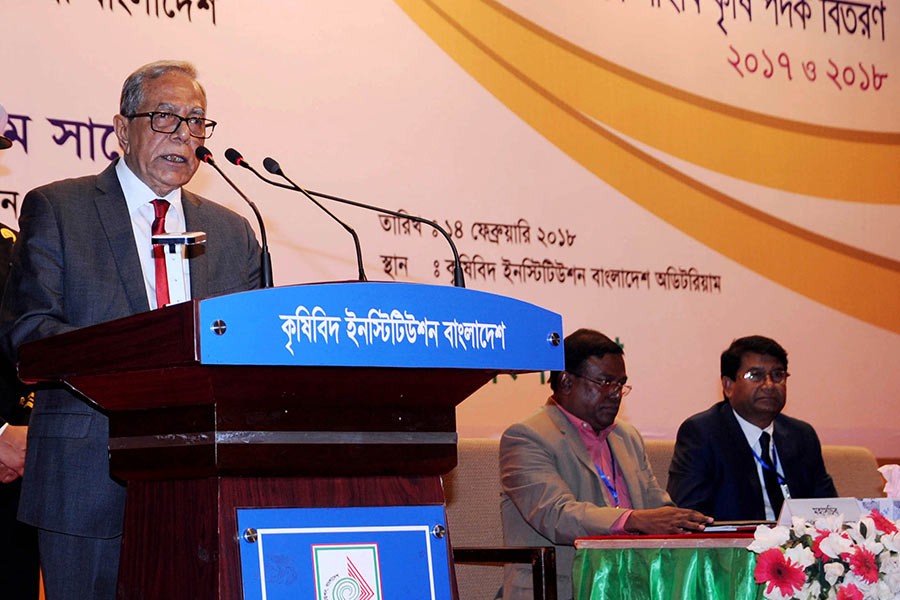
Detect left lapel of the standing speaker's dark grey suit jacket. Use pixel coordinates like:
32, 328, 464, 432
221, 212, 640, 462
93, 163, 150, 313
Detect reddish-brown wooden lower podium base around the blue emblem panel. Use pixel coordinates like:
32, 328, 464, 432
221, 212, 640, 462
117, 475, 446, 600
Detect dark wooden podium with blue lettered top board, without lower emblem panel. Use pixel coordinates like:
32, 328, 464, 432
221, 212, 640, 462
19, 282, 564, 599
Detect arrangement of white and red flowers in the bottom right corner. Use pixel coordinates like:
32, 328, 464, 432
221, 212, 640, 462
748, 510, 900, 600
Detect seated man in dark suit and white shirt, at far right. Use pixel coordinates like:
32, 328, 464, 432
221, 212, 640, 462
667, 335, 837, 521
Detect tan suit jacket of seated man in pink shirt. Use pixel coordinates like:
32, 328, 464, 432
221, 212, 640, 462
500, 403, 672, 600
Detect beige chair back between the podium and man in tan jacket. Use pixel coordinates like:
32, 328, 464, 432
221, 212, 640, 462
444, 438, 503, 600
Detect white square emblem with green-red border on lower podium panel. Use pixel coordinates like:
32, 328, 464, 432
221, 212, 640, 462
312, 544, 382, 600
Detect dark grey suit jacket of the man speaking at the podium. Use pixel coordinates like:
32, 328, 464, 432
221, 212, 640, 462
0, 164, 260, 538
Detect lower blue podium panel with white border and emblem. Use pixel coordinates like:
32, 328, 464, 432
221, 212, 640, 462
237, 506, 451, 600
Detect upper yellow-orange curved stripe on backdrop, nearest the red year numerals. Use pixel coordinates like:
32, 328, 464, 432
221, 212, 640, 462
400, 0, 900, 204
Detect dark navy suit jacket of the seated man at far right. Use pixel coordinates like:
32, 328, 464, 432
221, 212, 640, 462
668, 401, 837, 521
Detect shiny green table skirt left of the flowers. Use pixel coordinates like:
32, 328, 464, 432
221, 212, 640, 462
572, 548, 763, 600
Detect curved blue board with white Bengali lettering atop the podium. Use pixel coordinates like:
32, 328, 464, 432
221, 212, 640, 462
199, 282, 564, 371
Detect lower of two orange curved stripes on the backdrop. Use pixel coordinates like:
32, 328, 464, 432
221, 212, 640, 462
397, 0, 900, 333
